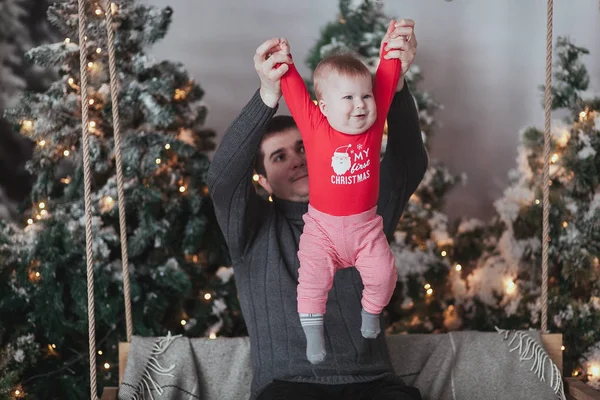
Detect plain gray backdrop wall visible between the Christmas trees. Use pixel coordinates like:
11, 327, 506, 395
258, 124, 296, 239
149, 0, 600, 217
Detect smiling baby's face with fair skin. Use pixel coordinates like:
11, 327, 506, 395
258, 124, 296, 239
319, 73, 377, 135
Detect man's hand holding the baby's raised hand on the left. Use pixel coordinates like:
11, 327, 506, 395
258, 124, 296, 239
254, 38, 292, 108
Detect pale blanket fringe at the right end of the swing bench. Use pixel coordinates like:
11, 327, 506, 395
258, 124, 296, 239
496, 327, 566, 400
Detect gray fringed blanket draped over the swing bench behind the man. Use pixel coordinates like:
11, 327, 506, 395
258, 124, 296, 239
119, 330, 565, 400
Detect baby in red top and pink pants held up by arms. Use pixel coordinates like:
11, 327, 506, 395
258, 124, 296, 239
281, 21, 401, 364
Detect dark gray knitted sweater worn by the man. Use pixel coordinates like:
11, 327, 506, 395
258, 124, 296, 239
208, 84, 428, 399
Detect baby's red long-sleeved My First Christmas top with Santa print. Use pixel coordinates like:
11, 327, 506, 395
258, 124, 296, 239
281, 52, 400, 216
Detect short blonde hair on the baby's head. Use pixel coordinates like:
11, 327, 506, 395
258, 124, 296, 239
313, 53, 371, 100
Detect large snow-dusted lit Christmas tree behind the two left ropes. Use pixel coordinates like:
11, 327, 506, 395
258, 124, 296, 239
0, 0, 239, 399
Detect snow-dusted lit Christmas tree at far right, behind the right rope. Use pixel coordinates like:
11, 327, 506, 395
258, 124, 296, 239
448, 37, 600, 389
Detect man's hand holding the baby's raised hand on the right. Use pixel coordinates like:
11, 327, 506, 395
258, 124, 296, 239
381, 19, 417, 91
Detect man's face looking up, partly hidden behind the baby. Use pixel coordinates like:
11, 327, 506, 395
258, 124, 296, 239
258, 128, 308, 202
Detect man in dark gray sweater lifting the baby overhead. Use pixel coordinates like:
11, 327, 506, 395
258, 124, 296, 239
208, 20, 427, 400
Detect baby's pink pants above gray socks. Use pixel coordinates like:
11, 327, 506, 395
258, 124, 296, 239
298, 205, 398, 314
